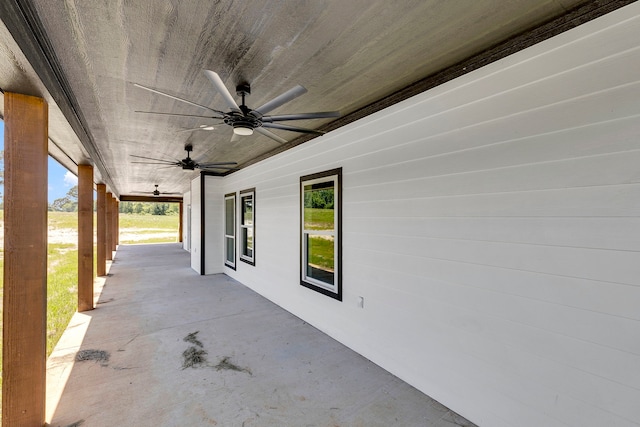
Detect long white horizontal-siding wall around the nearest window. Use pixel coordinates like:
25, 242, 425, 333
209, 3, 640, 427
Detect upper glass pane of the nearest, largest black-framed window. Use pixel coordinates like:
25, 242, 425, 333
304, 180, 335, 230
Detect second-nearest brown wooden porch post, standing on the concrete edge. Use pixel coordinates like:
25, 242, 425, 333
78, 165, 93, 311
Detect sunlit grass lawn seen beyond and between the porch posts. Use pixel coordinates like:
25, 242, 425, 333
0, 210, 179, 409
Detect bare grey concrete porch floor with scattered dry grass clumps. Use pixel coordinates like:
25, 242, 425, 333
47, 244, 473, 427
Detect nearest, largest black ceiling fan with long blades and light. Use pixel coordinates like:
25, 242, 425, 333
134, 70, 340, 143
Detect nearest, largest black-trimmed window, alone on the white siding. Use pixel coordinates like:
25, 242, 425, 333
300, 168, 342, 301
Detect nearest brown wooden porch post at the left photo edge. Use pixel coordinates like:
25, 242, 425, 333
2, 92, 48, 426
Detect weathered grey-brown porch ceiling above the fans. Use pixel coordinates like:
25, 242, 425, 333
0, 0, 620, 195
